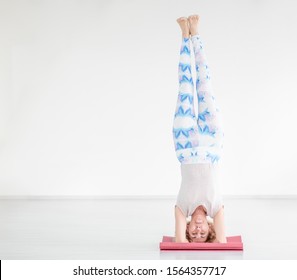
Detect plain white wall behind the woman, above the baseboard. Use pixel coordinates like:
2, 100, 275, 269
0, 0, 297, 195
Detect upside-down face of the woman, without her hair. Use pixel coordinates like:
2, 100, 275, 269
188, 215, 209, 242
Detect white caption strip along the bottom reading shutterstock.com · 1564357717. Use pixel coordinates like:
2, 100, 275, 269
2, 259, 296, 280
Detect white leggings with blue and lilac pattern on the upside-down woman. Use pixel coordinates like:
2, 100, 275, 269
172, 34, 224, 164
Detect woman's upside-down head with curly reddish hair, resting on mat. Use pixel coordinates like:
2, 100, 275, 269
186, 206, 216, 242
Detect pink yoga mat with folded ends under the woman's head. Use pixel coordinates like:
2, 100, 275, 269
160, 235, 243, 251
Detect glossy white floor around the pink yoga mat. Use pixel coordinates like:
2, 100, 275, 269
0, 199, 297, 260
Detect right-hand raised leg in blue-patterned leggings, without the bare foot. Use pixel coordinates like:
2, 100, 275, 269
191, 34, 224, 163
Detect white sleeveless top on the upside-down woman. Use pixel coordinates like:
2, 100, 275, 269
176, 163, 223, 218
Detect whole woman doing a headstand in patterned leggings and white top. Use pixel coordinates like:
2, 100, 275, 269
172, 15, 226, 243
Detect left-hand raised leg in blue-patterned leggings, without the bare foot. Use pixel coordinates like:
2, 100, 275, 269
172, 37, 198, 163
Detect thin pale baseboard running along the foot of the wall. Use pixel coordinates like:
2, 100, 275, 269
0, 194, 297, 200
